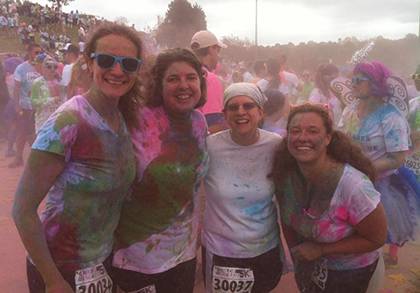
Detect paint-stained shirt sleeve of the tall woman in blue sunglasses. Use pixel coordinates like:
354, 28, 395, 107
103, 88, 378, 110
32, 111, 78, 162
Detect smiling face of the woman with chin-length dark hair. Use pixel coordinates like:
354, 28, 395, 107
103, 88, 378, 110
162, 61, 201, 114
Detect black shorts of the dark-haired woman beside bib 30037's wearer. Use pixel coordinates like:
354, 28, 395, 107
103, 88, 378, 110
112, 259, 197, 293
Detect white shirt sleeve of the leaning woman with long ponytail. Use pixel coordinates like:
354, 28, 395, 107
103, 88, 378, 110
348, 175, 380, 226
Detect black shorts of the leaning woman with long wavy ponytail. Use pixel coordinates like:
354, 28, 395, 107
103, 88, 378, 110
295, 260, 378, 293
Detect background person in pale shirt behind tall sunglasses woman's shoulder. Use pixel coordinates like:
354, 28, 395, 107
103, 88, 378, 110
31, 54, 64, 133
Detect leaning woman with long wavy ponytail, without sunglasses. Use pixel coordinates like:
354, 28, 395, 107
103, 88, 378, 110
272, 104, 386, 293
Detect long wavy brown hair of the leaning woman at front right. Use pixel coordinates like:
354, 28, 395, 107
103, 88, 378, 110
271, 103, 375, 189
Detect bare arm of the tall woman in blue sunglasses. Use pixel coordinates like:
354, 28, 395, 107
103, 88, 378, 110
12, 150, 73, 292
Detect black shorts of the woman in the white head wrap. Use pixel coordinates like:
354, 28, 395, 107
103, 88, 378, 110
202, 246, 283, 293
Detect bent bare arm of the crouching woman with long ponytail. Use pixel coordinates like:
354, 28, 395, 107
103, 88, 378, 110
292, 203, 387, 261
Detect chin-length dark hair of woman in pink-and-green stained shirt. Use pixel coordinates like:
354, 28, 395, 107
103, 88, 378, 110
147, 48, 207, 108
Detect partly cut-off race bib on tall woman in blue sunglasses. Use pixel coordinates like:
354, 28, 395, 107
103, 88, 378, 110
74, 264, 112, 293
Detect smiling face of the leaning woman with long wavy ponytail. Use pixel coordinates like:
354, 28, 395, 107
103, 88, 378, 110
287, 113, 331, 163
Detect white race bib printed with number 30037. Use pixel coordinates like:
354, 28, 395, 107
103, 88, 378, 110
212, 266, 254, 293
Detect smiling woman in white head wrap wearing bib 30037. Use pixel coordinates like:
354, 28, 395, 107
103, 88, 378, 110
202, 83, 283, 293
